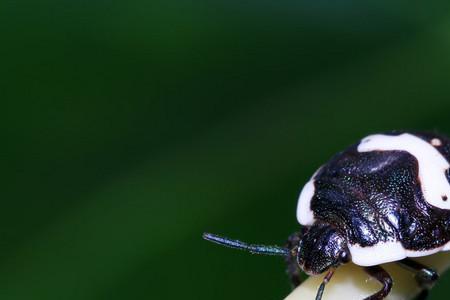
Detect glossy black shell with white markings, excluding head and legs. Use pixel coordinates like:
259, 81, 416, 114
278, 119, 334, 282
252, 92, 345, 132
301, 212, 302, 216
297, 132, 450, 266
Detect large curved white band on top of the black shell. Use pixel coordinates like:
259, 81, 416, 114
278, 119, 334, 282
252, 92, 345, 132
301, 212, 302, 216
358, 133, 450, 209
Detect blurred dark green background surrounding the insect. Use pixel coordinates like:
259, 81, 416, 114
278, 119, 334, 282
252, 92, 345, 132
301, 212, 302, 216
0, 0, 450, 300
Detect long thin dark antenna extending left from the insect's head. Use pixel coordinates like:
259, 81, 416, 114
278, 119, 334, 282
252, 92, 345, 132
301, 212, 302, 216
203, 233, 291, 256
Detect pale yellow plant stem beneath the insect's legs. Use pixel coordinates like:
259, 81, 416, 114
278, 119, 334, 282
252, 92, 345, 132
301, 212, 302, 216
285, 252, 450, 300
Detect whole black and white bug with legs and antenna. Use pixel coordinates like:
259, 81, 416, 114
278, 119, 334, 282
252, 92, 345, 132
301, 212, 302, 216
203, 131, 450, 300
